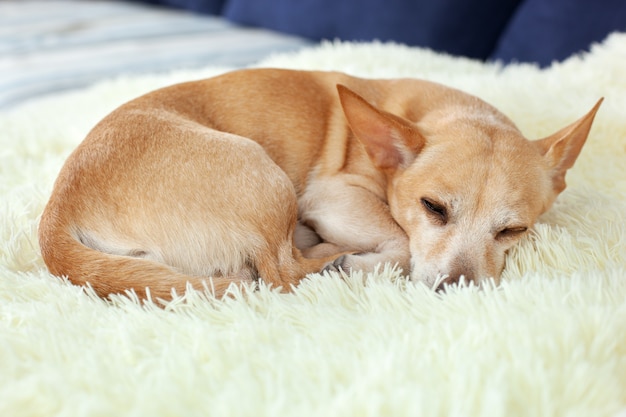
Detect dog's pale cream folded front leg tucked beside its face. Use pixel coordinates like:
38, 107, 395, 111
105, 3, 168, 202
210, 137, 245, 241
299, 176, 410, 274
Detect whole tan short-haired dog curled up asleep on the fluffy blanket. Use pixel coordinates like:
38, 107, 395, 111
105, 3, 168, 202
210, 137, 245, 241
39, 69, 601, 298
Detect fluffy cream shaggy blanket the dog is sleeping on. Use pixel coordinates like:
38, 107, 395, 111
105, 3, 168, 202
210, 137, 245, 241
0, 34, 626, 417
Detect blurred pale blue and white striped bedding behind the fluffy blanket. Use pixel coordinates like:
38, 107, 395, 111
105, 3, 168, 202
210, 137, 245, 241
0, 0, 308, 109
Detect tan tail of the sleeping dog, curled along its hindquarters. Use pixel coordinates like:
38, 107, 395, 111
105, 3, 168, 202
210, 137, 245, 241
39, 210, 253, 300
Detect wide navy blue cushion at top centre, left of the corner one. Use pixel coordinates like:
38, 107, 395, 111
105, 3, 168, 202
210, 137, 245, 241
223, 0, 520, 59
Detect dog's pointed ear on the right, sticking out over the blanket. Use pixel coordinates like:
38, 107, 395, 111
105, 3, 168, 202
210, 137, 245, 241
534, 99, 603, 194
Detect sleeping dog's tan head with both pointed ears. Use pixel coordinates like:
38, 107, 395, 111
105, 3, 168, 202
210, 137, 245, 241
338, 86, 601, 285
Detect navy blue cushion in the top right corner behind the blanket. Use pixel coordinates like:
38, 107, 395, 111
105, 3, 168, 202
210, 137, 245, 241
491, 0, 626, 66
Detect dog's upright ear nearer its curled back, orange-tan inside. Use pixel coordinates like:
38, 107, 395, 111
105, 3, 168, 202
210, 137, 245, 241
337, 84, 426, 170
